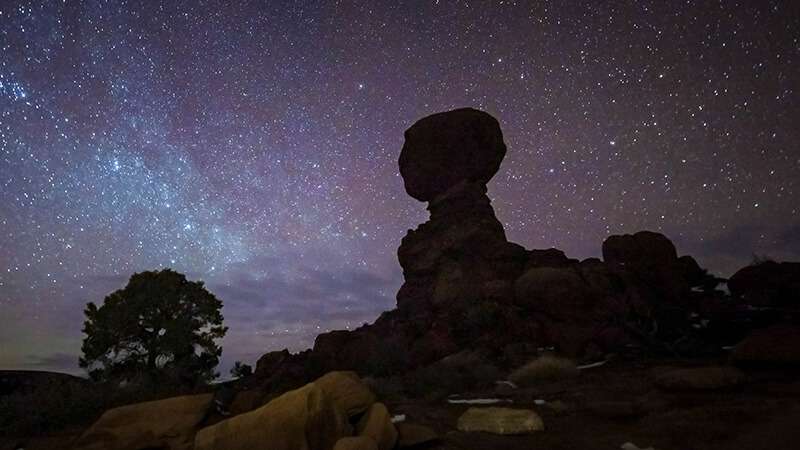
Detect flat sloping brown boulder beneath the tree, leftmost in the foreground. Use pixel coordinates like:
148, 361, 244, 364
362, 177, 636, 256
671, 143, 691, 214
74, 394, 213, 450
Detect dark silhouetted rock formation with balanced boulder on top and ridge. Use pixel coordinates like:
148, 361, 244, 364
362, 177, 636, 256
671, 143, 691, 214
242, 108, 800, 398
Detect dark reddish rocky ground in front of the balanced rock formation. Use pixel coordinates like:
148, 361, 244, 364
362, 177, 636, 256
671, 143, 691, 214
6, 360, 800, 450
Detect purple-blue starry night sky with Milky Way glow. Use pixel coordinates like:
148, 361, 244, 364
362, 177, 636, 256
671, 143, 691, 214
0, 0, 800, 373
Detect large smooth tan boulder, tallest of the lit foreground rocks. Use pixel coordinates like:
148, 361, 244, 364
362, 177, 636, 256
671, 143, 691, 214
194, 383, 352, 450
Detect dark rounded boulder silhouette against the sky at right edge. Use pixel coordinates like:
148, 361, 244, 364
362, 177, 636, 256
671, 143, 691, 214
728, 261, 800, 307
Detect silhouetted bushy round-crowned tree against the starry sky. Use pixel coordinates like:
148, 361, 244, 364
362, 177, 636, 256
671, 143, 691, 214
80, 269, 227, 385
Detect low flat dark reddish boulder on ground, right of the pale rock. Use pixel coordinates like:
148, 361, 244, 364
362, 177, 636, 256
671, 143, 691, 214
655, 366, 747, 391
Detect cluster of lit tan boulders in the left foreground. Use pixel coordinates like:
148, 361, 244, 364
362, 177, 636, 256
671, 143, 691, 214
74, 372, 437, 450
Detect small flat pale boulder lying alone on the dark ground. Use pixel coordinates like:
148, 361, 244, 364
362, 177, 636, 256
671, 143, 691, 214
457, 407, 544, 434
